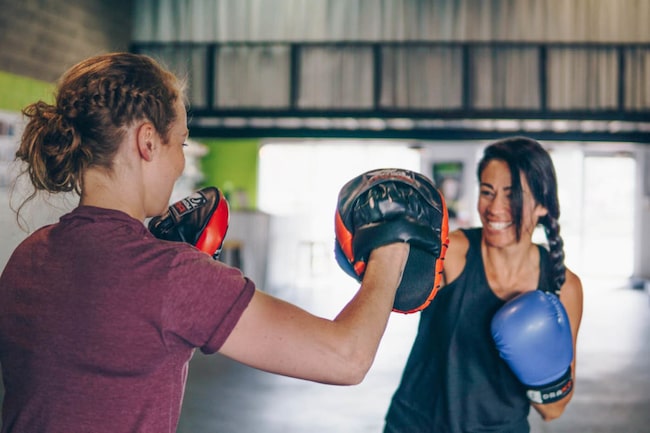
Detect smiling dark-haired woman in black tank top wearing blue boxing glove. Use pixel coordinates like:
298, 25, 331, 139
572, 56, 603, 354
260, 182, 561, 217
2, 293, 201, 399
385, 137, 582, 433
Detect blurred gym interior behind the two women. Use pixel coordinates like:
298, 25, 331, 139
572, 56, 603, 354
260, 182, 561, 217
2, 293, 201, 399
0, 0, 650, 432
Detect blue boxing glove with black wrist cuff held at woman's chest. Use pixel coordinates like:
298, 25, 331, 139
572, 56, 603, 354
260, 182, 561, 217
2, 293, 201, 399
491, 290, 573, 404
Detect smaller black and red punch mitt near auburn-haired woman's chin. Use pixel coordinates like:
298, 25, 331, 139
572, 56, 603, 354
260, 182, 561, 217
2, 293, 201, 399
149, 186, 230, 260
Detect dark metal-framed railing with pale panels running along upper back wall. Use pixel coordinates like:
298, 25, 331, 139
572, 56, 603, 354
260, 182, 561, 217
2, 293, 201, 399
132, 41, 650, 142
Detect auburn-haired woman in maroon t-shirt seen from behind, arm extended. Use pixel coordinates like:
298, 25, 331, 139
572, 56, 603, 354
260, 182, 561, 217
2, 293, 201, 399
0, 53, 409, 433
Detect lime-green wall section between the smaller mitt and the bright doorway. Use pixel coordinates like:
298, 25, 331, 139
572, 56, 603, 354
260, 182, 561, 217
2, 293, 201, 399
197, 139, 260, 210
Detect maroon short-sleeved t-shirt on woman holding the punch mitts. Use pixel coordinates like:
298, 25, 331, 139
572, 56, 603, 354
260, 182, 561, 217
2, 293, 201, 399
0, 206, 254, 433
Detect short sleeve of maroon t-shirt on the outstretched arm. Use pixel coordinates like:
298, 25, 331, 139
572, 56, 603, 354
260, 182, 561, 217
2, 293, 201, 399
162, 246, 255, 354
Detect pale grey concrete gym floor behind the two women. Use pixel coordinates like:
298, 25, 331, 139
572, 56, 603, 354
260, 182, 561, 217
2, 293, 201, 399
172, 280, 650, 433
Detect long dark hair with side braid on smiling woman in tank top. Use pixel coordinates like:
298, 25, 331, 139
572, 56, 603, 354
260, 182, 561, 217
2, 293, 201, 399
477, 137, 566, 294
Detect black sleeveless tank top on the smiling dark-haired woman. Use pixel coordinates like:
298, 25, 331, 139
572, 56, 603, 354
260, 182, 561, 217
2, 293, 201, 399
384, 228, 551, 433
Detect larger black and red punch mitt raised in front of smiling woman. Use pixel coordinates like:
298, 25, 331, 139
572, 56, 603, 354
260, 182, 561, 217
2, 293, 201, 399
335, 168, 448, 313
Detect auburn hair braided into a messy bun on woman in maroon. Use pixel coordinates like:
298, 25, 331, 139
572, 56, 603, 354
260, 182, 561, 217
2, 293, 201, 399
16, 53, 184, 212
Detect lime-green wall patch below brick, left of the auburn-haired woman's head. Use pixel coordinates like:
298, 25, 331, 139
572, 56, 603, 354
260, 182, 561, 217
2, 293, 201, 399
0, 71, 55, 112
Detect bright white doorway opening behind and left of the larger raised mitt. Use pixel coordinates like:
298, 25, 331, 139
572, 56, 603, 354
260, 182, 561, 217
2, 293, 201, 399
258, 140, 420, 308
